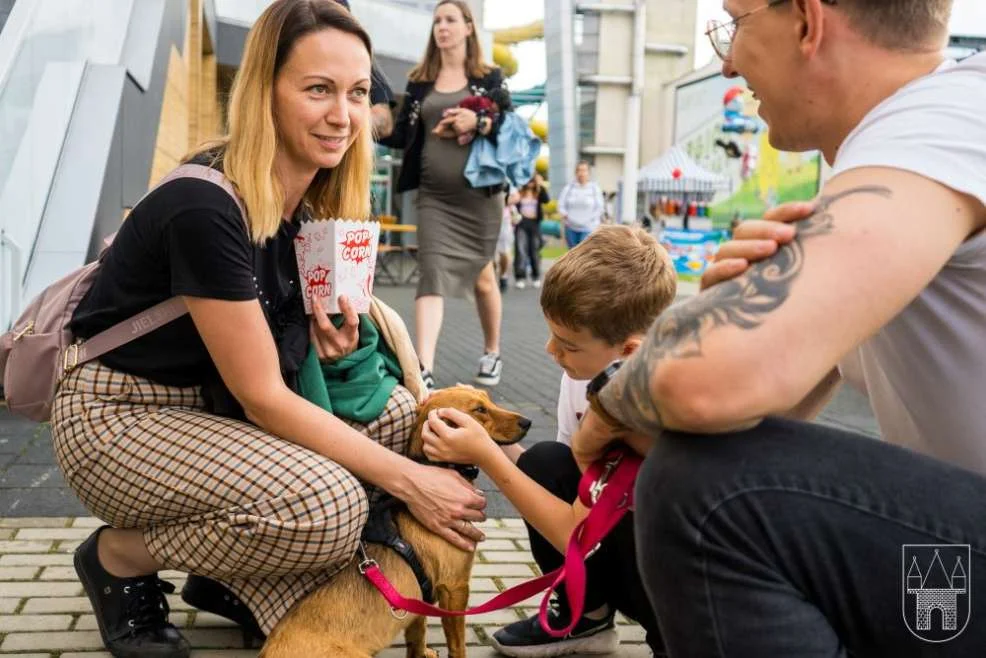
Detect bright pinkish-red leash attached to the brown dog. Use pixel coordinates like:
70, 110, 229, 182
359, 449, 641, 637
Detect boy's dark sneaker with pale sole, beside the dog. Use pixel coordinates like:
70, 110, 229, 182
493, 599, 620, 658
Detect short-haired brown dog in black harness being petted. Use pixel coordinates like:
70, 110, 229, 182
260, 386, 531, 658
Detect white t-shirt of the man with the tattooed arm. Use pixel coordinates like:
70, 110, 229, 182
833, 54, 986, 473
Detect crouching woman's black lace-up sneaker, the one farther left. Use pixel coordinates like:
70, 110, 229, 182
73, 526, 191, 658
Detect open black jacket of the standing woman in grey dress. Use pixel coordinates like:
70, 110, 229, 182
380, 68, 512, 192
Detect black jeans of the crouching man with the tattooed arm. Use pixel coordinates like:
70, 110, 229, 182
636, 419, 986, 658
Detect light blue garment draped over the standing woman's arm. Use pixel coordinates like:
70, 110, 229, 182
463, 112, 541, 187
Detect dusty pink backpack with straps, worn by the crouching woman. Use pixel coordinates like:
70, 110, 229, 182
0, 164, 246, 422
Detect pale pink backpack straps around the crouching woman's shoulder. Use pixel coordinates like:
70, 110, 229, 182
63, 163, 247, 373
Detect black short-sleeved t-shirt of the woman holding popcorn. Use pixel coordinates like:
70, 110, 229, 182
71, 169, 308, 398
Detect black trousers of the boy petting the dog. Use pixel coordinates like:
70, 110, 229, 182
517, 441, 663, 655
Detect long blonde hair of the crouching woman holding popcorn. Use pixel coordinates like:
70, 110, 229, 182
186, 0, 373, 244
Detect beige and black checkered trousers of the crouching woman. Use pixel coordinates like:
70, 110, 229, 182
51, 363, 417, 632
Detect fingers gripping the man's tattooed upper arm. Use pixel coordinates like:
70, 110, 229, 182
701, 201, 815, 290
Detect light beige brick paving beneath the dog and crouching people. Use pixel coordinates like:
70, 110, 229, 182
0, 517, 650, 658
